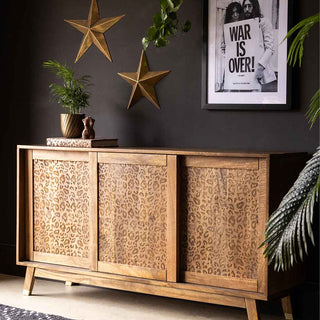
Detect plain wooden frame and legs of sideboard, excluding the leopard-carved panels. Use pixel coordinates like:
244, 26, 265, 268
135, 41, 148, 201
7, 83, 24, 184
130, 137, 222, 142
17, 146, 306, 320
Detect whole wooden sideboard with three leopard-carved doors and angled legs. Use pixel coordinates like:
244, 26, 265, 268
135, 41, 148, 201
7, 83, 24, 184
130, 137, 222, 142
17, 146, 307, 320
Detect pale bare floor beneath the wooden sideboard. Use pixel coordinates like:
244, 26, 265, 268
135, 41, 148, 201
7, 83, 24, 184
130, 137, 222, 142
0, 274, 284, 320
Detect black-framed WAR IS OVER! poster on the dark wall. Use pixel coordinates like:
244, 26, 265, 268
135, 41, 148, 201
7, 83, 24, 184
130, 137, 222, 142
202, 0, 291, 110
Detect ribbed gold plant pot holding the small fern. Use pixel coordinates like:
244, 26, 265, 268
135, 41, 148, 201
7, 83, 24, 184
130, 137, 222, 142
60, 113, 85, 138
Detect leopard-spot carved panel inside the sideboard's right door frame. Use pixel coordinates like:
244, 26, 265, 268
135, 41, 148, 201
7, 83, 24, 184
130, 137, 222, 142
180, 167, 259, 279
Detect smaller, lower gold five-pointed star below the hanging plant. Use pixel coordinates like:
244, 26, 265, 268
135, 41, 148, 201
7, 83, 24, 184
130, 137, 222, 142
118, 50, 170, 109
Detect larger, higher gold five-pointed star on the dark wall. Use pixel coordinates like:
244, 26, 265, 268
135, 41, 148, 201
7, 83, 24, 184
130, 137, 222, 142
65, 0, 125, 63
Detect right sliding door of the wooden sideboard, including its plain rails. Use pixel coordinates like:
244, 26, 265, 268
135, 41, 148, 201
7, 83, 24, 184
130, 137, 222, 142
180, 156, 268, 292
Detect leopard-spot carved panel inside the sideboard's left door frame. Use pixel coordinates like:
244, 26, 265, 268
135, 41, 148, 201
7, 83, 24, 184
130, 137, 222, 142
33, 160, 89, 258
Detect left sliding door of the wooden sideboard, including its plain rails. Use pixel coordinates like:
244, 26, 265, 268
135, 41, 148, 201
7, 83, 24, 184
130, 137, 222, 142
27, 150, 89, 268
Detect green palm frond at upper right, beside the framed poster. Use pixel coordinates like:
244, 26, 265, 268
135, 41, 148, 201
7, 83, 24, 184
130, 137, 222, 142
282, 13, 320, 67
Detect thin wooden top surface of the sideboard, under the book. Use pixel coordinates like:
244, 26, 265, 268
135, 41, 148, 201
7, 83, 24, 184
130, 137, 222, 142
17, 145, 306, 157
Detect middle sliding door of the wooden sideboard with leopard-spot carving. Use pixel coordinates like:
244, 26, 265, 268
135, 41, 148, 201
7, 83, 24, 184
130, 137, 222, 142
98, 153, 174, 280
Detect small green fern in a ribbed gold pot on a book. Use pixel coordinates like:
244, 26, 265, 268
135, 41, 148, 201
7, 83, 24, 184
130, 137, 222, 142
43, 60, 90, 138
